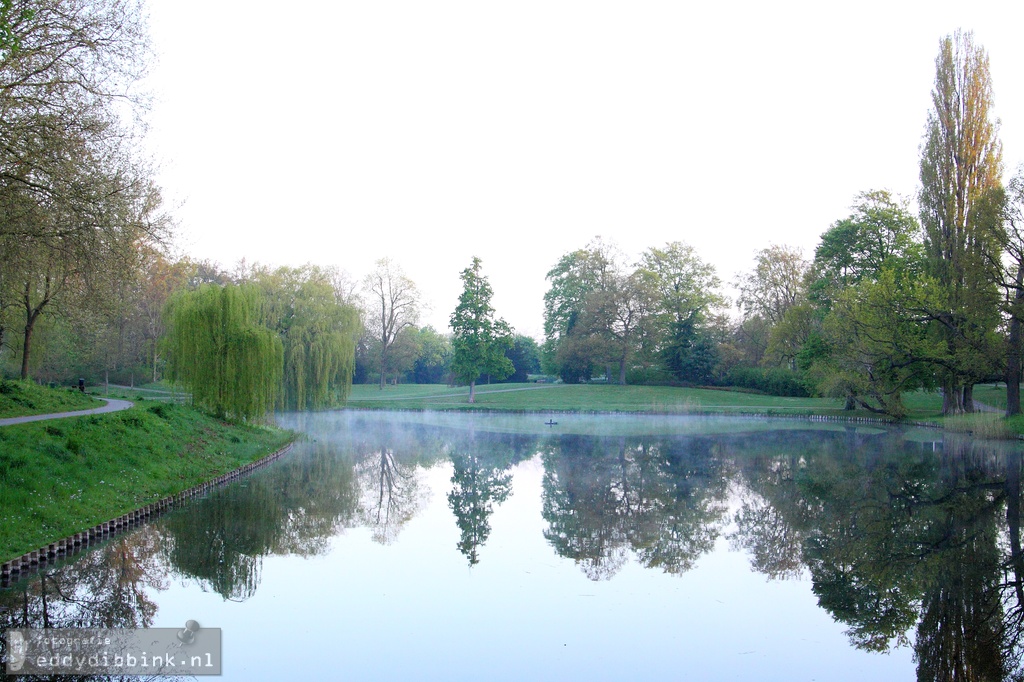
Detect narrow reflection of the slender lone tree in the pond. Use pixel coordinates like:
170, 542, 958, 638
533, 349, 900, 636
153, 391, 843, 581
447, 433, 536, 565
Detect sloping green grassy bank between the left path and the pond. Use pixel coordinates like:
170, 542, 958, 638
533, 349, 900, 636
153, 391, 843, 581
0, 403, 293, 561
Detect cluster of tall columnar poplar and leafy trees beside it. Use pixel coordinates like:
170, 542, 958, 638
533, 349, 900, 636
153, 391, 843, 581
768, 33, 1024, 416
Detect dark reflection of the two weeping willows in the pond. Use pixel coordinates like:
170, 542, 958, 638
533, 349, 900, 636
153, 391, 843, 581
162, 442, 356, 600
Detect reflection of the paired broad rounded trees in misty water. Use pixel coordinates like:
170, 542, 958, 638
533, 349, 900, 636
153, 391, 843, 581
544, 436, 727, 580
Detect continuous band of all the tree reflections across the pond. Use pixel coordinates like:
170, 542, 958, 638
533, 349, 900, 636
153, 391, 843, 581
9, 411, 1024, 680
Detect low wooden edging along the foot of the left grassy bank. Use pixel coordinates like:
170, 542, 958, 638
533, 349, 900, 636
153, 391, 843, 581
0, 443, 294, 587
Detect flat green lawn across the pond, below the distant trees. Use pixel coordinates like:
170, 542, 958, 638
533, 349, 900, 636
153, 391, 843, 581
348, 384, 942, 419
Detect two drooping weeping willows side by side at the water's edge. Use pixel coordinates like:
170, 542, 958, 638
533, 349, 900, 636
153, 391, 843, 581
164, 265, 361, 419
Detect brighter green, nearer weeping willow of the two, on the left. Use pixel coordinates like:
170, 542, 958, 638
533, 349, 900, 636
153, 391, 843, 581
167, 285, 284, 420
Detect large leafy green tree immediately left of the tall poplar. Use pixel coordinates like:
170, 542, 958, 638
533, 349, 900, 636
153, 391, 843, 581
802, 190, 937, 409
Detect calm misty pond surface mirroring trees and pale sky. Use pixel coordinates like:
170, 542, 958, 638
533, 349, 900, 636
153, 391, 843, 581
0, 412, 1024, 681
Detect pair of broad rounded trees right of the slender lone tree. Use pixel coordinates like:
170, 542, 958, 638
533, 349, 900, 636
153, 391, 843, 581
543, 238, 725, 383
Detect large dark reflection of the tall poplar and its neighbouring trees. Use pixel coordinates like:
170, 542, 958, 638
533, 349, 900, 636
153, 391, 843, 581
740, 428, 1024, 680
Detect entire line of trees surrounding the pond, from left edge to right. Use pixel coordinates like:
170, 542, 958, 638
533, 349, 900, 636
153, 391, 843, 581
0, 13, 1024, 418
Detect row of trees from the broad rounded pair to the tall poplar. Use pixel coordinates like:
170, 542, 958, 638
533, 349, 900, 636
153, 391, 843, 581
544, 33, 1024, 416
